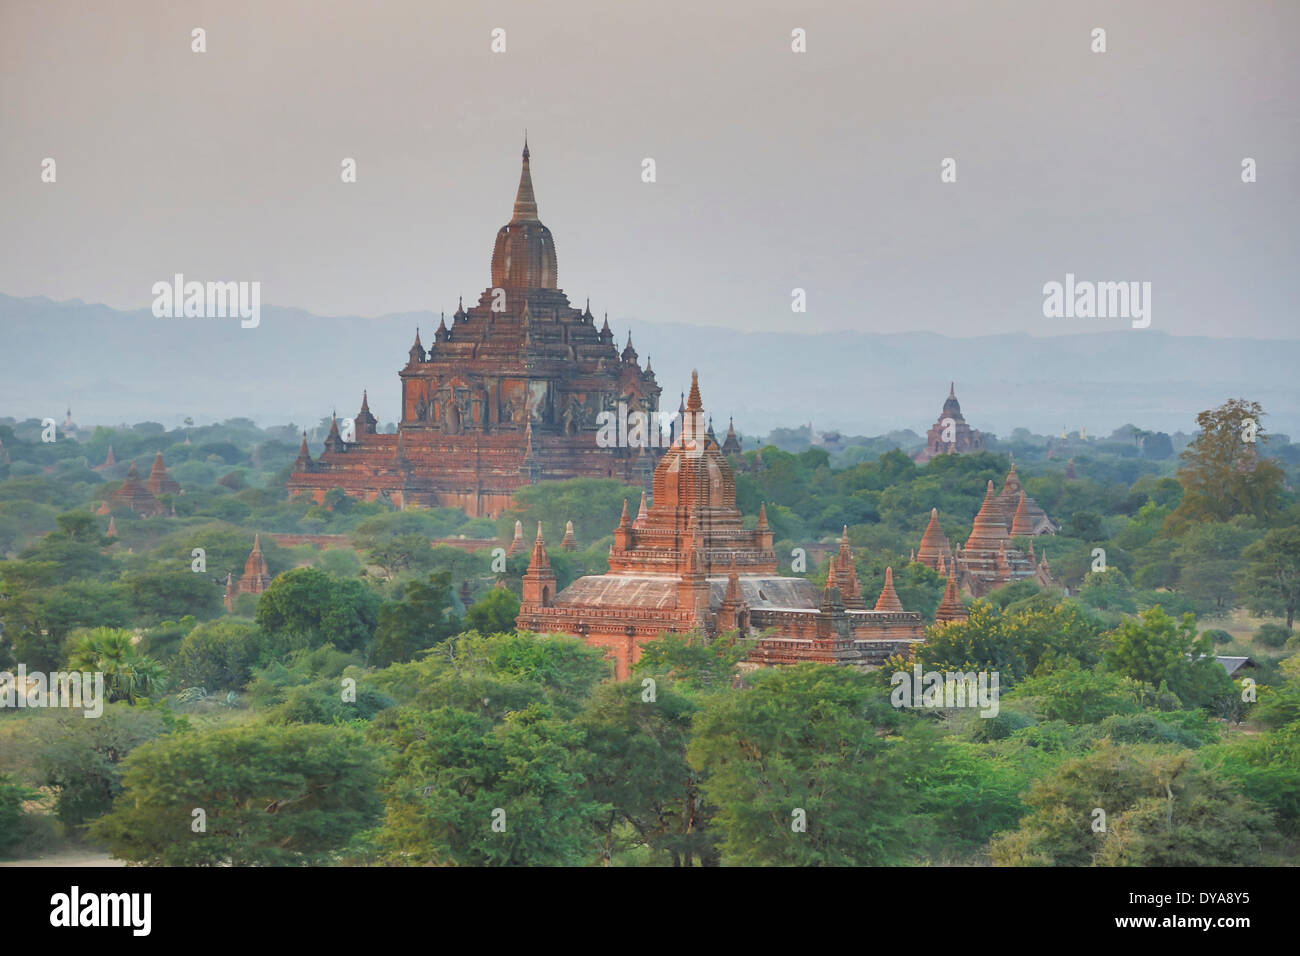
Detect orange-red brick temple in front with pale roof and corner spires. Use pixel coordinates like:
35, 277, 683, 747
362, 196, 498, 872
517, 373, 923, 679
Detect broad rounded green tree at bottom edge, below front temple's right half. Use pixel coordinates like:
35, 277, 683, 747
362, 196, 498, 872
686, 663, 914, 866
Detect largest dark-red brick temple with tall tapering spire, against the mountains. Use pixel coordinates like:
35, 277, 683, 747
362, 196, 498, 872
289, 143, 660, 518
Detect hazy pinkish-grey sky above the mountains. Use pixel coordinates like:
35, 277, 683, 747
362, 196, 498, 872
0, 0, 1300, 338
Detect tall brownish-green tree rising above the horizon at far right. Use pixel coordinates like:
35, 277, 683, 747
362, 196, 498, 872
1166, 398, 1286, 533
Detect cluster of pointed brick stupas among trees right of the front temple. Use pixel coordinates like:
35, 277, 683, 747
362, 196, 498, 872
917, 476, 1057, 600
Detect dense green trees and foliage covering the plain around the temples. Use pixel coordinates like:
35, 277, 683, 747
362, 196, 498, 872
0, 399, 1300, 866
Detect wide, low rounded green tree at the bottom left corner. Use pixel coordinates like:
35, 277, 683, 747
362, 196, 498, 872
91, 724, 380, 866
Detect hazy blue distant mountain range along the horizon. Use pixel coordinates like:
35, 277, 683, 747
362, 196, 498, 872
0, 294, 1300, 436
